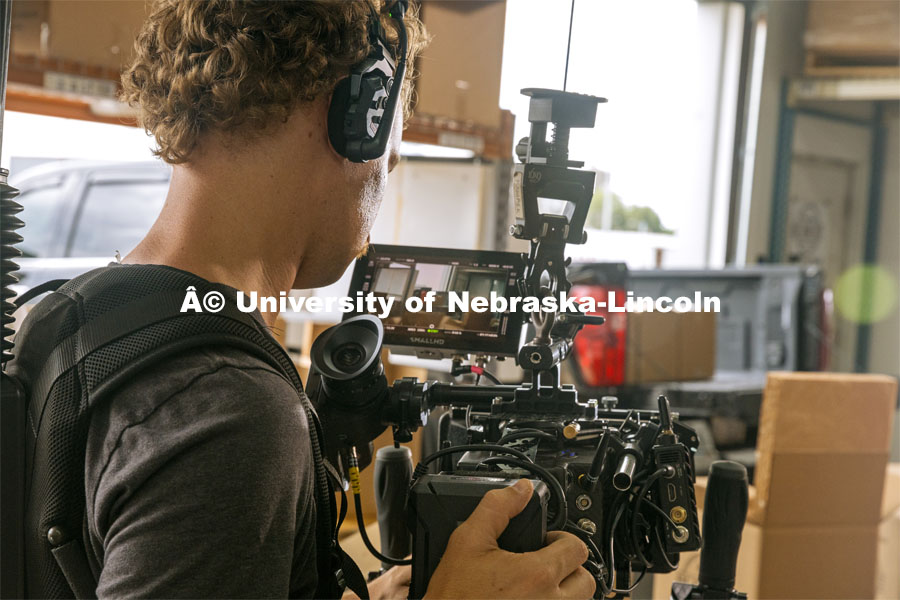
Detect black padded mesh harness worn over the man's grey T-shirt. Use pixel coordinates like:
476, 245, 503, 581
8, 264, 367, 598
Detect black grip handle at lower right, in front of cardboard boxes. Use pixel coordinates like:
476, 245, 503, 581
700, 460, 748, 590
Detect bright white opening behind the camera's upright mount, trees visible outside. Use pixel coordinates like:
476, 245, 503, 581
500, 0, 743, 268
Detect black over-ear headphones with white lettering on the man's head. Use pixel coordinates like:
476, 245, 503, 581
328, 0, 409, 163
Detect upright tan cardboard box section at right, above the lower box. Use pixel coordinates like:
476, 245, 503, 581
755, 373, 897, 527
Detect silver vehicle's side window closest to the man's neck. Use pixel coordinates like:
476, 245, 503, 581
68, 180, 169, 257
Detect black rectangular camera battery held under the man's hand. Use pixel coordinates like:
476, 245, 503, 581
408, 474, 550, 598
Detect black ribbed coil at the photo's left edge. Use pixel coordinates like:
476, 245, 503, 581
0, 169, 25, 367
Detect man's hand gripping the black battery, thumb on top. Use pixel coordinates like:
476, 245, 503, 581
426, 479, 595, 599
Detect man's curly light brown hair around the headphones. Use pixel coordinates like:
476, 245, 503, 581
121, 0, 427, 164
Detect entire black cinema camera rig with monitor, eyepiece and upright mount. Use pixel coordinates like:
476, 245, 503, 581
307, 89, 700, 598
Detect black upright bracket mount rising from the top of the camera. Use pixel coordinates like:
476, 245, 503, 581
500, 88, 606, 419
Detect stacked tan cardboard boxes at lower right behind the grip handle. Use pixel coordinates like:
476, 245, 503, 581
654, 373, 900, 599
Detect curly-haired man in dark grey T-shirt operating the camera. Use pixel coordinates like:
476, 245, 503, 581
29, 0, 593, 598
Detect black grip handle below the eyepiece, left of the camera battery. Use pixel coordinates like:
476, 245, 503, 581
374, 446, 412, 569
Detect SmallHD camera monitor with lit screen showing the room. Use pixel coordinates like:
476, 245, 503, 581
345, 244, 524, 358
